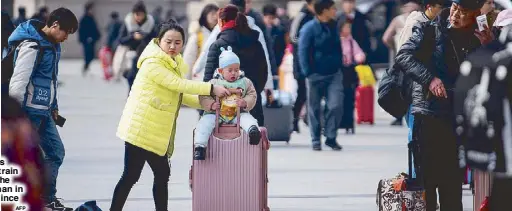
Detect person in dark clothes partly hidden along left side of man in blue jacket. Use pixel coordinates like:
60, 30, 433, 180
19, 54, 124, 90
290, 0, 315, 132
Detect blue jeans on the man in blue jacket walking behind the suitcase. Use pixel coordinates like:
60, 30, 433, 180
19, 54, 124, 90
308, 72, 343, 145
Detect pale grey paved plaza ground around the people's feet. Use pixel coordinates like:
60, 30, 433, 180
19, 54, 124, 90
57, 60, 472, 211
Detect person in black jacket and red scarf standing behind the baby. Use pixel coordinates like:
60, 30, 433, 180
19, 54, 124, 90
204, 4, 268, 126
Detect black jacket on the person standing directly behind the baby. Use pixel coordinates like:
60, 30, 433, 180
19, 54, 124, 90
203, 29, 268, 93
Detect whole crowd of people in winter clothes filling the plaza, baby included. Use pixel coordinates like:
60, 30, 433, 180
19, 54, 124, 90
2, 0, 512, 211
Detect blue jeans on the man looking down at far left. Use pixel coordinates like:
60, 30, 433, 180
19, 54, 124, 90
28, 113, 65, 203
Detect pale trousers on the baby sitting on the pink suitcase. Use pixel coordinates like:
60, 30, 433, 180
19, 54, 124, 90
194, 113, 258, 147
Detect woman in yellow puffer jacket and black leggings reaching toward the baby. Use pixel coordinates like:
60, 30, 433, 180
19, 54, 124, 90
110, 20, 229, 211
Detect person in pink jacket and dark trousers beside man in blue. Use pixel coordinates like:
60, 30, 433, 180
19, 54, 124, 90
339, 21, 366, 133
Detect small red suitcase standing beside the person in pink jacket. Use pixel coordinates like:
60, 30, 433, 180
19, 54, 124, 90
356, 86, 375, 125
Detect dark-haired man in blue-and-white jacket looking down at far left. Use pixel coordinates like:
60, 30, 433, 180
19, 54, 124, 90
9, 8, 78, 211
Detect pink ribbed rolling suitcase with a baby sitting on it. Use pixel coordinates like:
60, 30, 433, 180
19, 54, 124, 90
189, 109, 270, 211
